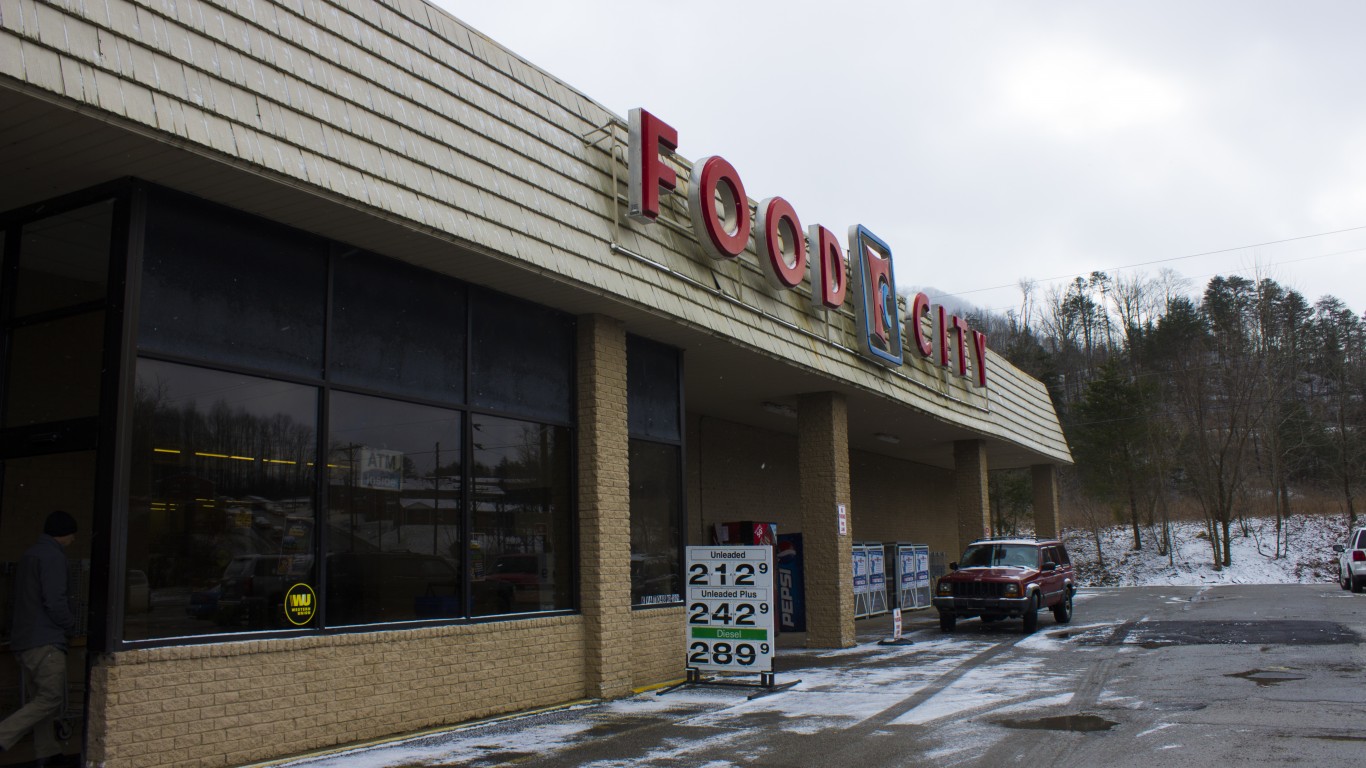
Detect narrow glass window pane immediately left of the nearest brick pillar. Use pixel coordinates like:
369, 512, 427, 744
469, 415, 574, 616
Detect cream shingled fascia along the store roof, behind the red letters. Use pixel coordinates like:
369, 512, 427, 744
0, 0, 1067, 461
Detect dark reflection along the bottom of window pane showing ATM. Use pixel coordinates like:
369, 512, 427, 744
326, 552, 462, 625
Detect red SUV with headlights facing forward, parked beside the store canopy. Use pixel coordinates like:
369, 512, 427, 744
934, 538, 1076, 634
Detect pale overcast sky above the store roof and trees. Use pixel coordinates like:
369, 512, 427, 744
437, 0, 1366, 313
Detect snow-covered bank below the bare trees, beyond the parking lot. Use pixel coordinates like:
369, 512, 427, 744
1063, 515, 1347, 586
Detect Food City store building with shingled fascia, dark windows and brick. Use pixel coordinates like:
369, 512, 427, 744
0, 0, 1070, 768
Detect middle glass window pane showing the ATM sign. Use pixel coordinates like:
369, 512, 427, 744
326, 392, 464, 626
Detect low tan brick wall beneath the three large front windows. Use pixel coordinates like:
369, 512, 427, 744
89, 616, 585, 768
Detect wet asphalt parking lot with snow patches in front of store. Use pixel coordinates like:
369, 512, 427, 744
263, 585, 1366, 768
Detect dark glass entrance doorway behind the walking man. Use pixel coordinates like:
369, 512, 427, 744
0, 191, 121, 768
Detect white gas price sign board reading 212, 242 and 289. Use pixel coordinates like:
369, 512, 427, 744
686, 547, 773, 674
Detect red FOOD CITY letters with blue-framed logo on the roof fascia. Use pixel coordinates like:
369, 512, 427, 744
628, 108, 986, 387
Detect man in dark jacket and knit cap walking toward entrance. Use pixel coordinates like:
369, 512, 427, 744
0, 510, 76, 765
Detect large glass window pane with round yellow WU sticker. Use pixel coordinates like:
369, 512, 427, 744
124, 359, 318, 640
